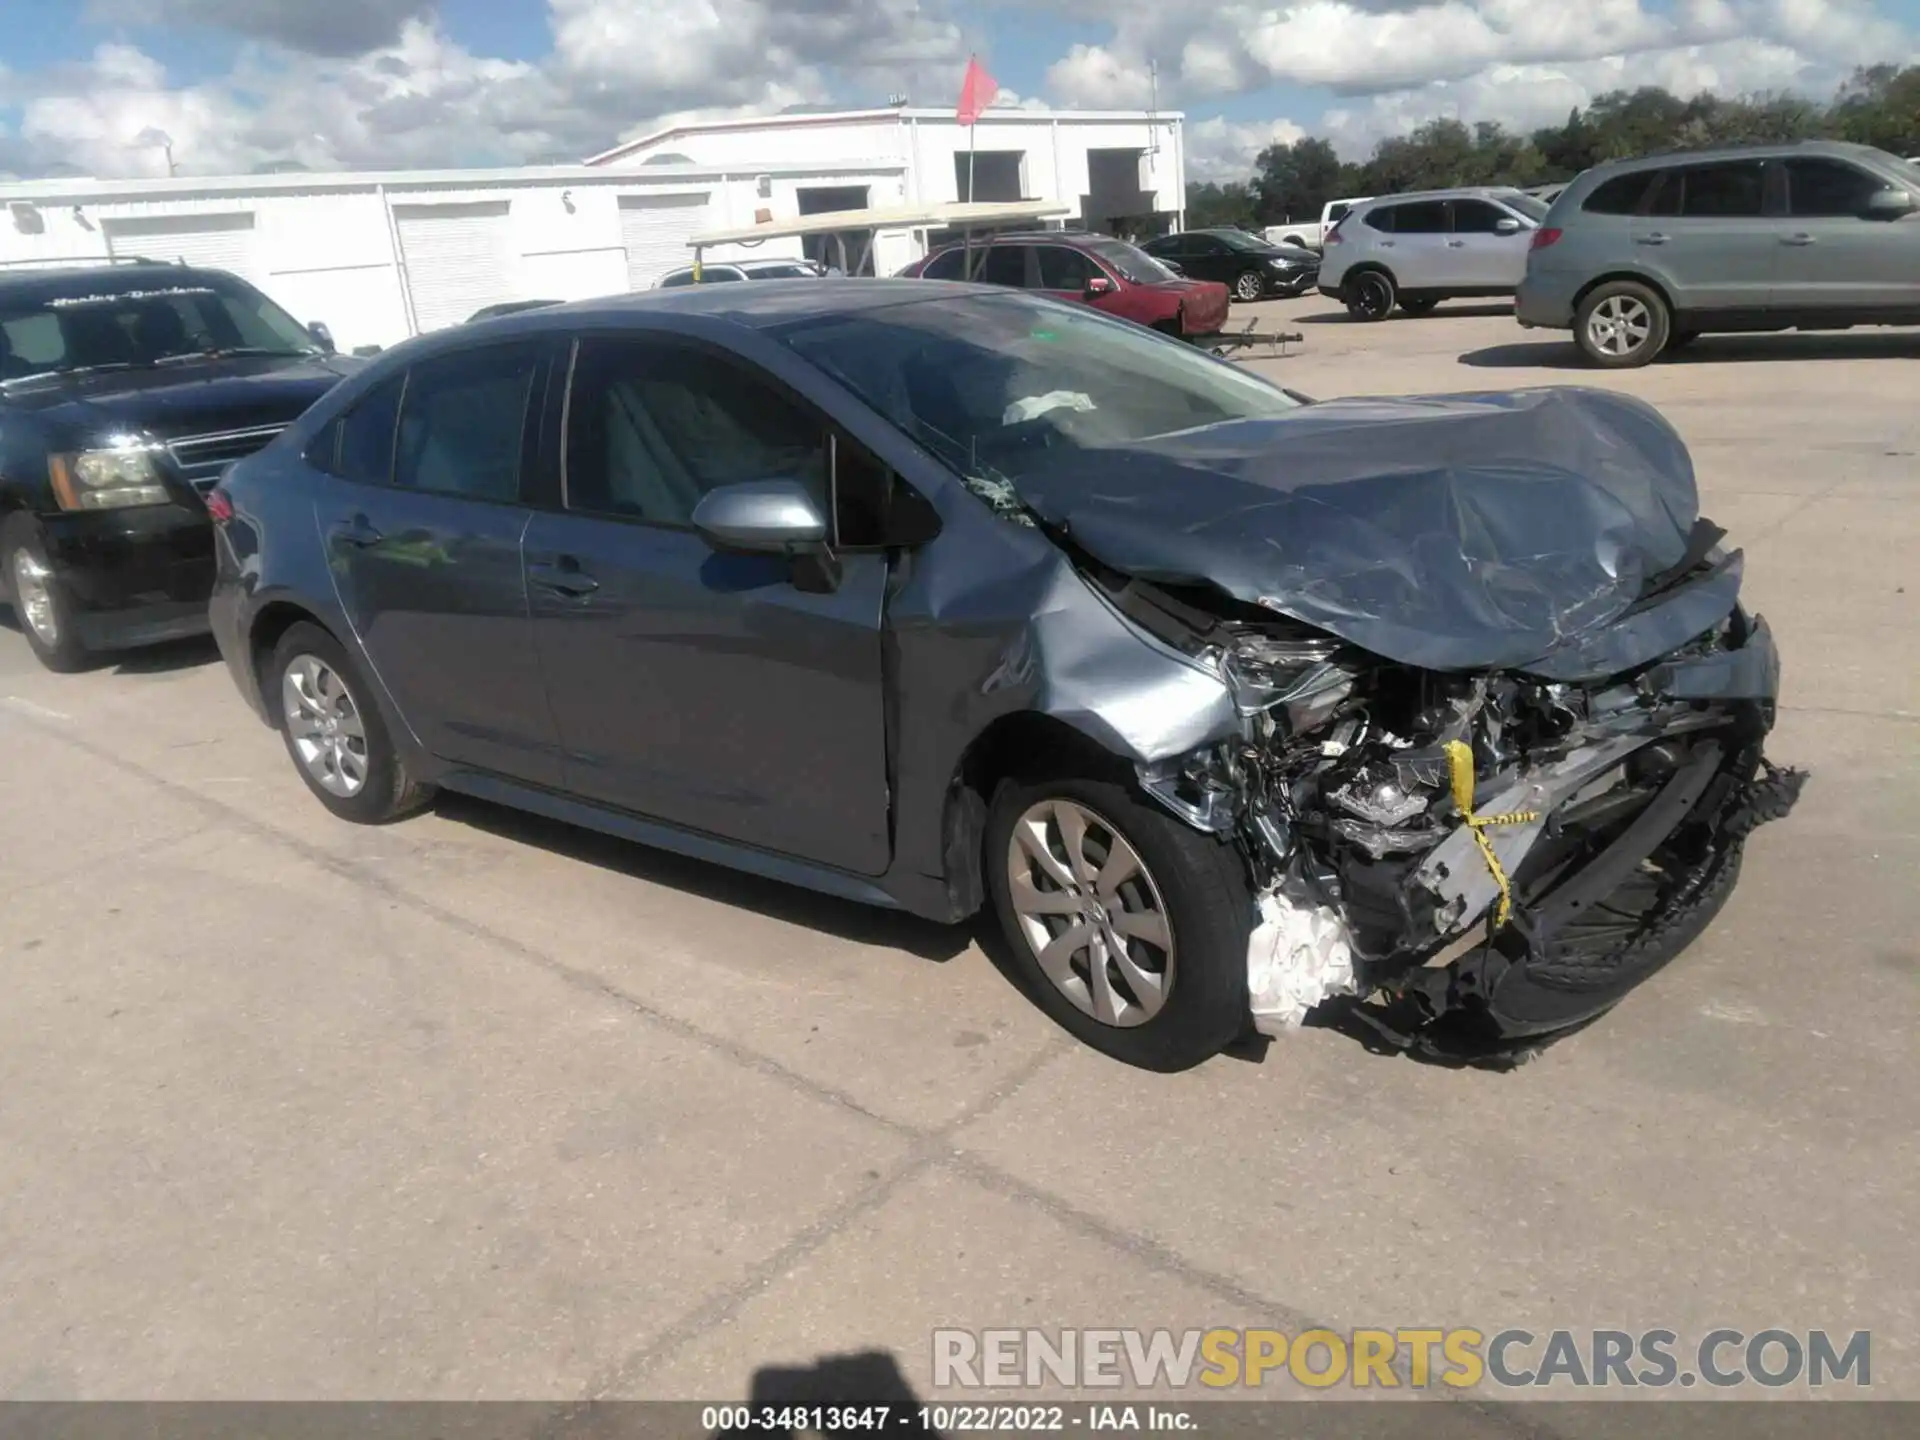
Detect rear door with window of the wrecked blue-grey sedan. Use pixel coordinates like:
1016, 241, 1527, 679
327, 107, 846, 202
315, 344, 561, 785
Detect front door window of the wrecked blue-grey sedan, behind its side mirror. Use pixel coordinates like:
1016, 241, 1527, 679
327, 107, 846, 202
566, 340, 828, 526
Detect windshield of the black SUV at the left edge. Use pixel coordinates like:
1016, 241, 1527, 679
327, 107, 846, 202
0, 276, 323, 380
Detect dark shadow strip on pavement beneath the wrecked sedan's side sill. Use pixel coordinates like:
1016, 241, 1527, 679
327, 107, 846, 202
434, 791, 970, 962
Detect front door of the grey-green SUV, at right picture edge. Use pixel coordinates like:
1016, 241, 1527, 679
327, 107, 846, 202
1778, 156, 1920, 315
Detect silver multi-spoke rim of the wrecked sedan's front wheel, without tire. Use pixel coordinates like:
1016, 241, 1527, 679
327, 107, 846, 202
1006, 801, 1173, 1029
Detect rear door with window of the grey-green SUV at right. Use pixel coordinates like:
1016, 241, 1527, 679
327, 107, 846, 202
1632, 159, 1780, 311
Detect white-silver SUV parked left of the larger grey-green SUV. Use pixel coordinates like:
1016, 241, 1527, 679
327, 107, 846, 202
1319, 188, 1548, 321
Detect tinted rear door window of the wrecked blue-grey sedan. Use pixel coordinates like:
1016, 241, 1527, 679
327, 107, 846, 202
394, 344, 541, 501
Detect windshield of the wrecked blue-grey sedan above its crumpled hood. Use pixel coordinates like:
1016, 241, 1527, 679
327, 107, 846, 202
778, 294, 1298, 488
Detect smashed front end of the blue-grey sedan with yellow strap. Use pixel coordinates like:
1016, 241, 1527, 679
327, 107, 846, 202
1102, 572, 1805, 1050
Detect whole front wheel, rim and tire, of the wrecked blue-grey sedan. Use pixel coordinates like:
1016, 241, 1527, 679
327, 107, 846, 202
983, 778, 1254, 1071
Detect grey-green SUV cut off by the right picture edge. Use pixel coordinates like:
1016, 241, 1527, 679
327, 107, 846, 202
1515, 140, 1920, 369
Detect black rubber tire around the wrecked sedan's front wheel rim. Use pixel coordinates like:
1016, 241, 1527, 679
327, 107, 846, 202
981, 778, 1254, 1071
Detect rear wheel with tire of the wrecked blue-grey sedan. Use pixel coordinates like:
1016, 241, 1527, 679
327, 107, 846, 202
267, 624, 434, 826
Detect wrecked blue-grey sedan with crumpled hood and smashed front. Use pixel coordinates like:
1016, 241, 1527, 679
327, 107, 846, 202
209, 280, 1799, 1069
